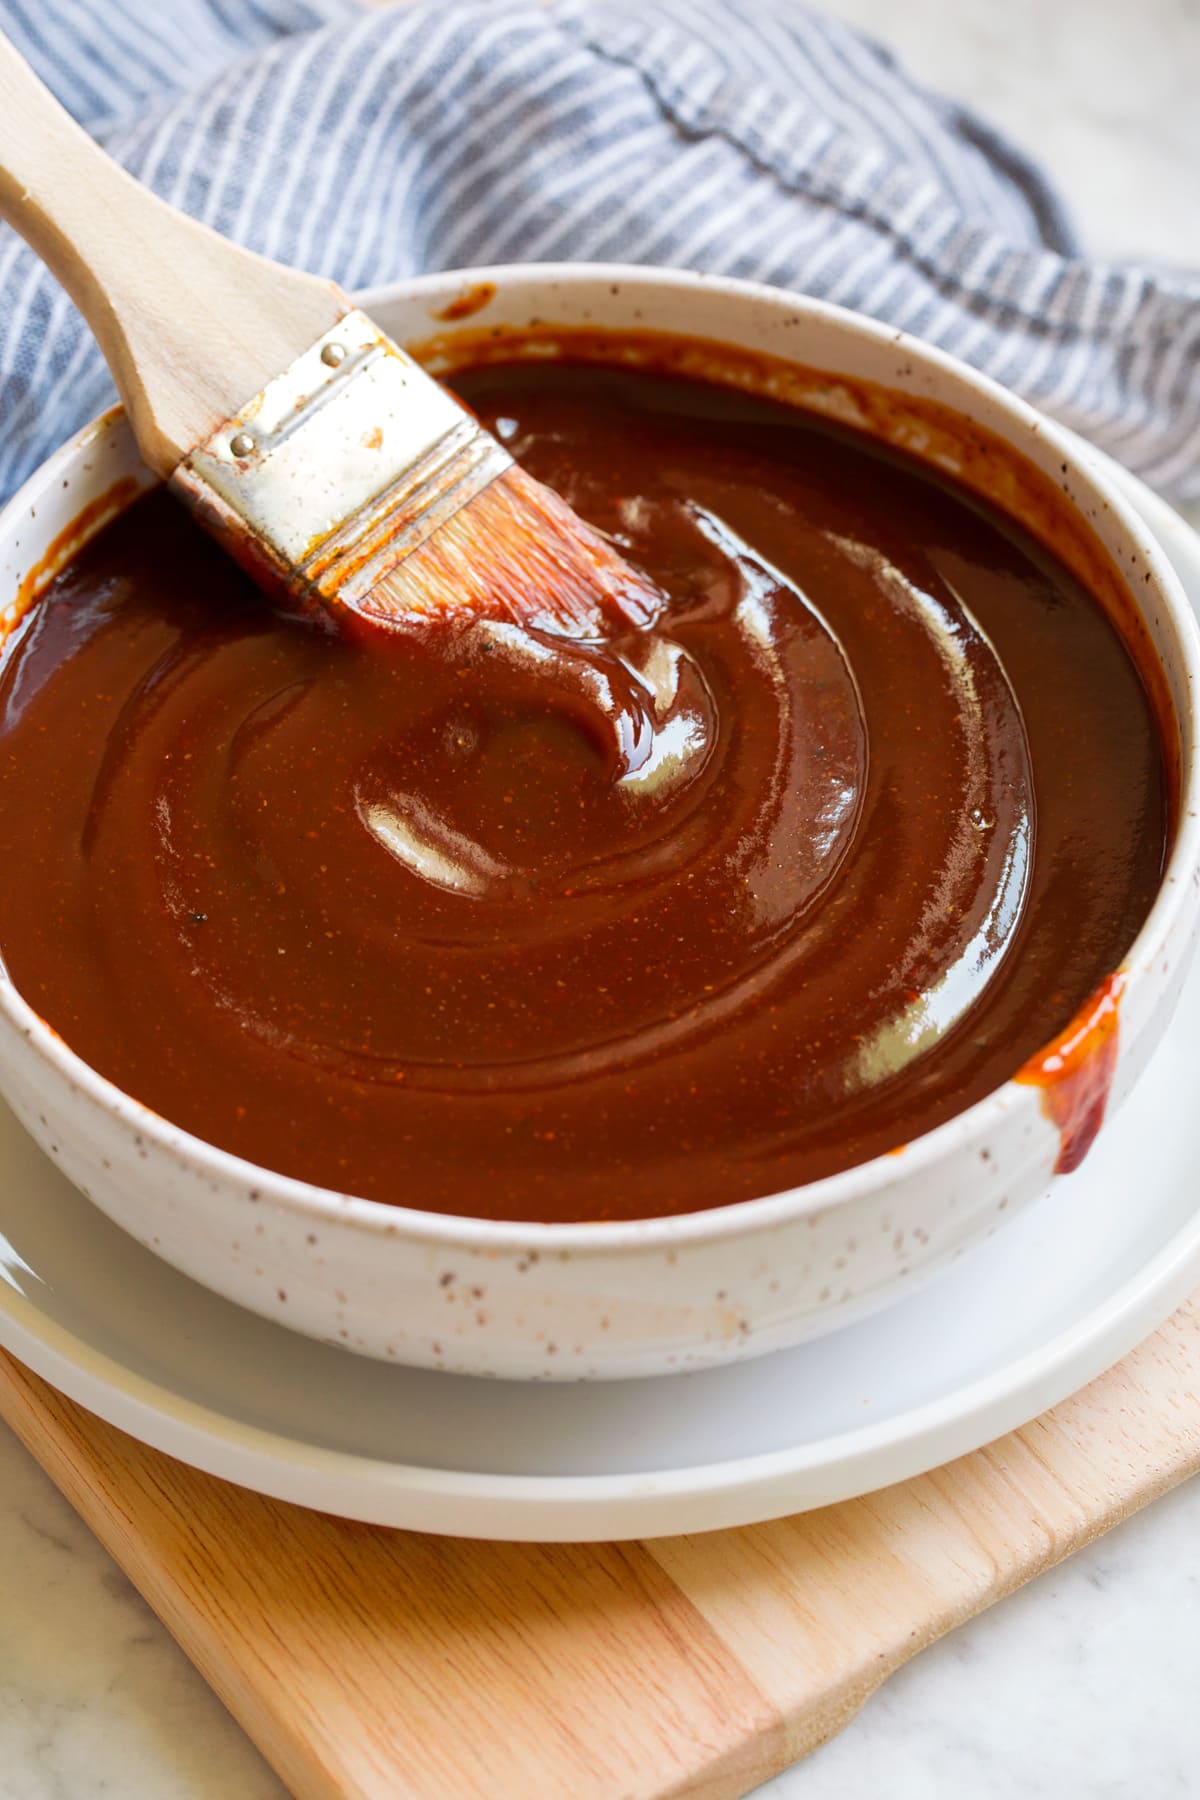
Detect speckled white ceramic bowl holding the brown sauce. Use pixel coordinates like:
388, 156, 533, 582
0, 266, 1200, 1379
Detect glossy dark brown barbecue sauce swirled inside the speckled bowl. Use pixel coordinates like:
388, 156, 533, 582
0, 364, 1168, 1220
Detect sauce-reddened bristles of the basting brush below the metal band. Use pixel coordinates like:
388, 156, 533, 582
351, 464, 662, 637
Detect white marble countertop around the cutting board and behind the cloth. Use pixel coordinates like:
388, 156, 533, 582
0, 0, 1200, 1800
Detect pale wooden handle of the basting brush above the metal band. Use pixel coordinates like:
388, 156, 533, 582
0, 36, 351, 475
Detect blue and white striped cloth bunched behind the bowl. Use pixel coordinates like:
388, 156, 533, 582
0, 0, 1200, 499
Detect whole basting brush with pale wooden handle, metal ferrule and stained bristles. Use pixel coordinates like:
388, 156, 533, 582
0, 36, 658, 637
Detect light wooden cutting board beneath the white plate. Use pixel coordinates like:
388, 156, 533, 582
0, 1296, 1200, 1800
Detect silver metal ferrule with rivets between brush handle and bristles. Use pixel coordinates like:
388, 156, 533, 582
171, 311, 513, 607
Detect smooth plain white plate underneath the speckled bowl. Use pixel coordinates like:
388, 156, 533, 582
0, 457, 1200, 1541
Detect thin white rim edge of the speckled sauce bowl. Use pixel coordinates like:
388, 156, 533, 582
0, 263, 1200, 1256
